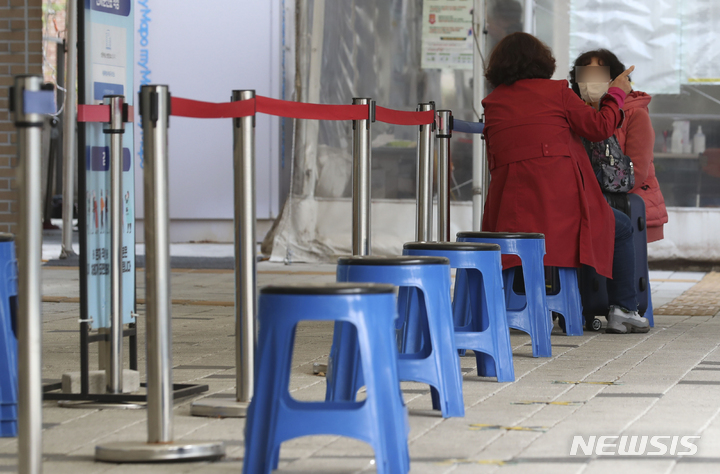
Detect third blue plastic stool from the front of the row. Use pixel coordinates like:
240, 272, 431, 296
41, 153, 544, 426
403, 242, 515, 382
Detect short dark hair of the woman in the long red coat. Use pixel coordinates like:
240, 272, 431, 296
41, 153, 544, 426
485, 32, 555, 87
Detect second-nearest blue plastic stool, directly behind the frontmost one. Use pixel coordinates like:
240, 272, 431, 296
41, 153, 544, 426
327, 257, 465, 418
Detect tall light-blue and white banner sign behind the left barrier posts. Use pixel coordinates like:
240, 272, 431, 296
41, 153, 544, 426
78, 0, 135, 328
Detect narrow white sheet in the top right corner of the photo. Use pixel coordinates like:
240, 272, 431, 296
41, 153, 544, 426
682, 0, 720, 84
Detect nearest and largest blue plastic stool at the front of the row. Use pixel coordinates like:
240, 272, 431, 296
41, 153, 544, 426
243, 283, 410, 474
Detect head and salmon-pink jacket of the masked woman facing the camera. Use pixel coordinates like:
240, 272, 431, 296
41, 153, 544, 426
570, 49, 668, 242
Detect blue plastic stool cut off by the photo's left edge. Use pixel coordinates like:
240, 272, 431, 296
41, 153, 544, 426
0, 233, 18, 437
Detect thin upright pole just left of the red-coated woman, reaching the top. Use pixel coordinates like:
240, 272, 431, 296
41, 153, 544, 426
472, 0, 487, 230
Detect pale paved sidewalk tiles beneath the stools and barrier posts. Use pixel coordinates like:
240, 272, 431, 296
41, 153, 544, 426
0, 262, 720, 474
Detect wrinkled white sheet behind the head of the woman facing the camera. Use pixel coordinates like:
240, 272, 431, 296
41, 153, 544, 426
570, 0, 681, 94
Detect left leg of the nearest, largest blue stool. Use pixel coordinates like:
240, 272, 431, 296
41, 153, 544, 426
243, 325, 295, 474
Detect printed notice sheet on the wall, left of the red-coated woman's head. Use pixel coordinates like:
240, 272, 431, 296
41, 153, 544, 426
421, 0, 473, 70
